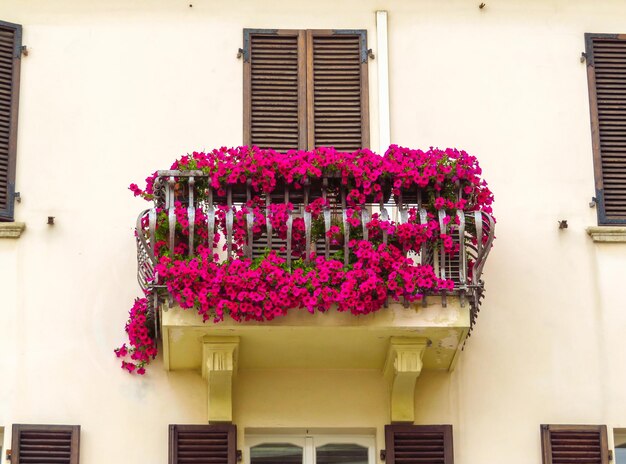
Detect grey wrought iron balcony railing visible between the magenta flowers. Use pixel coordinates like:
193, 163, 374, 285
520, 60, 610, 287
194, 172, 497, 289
136, 170, 495, 321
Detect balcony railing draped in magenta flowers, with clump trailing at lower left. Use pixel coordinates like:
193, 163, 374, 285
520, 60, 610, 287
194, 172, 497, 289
116, 145, 493, 374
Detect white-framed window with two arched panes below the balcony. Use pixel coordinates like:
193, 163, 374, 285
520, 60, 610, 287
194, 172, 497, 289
246, 434, 376, 464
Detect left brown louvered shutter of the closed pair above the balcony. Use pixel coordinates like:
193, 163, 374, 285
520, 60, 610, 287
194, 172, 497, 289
244, 29, 306, 152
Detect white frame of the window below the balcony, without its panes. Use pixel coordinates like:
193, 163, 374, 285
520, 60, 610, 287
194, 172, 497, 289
244, 433, 376, 464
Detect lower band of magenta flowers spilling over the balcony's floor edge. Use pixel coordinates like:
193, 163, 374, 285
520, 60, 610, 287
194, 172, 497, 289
156, 240, 454, 322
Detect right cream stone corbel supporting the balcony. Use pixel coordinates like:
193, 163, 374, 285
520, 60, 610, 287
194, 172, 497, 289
384, 337, 429, 423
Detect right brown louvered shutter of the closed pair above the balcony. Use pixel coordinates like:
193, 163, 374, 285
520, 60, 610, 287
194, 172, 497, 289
307, 30, 369, 151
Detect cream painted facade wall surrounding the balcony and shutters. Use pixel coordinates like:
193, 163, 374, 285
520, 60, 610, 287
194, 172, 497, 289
0, 0, 626, 464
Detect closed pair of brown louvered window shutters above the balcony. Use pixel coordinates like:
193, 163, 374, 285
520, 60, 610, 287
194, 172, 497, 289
243, 29, 369, 152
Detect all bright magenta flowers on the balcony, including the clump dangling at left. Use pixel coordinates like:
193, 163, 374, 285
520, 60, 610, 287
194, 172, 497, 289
115, 145, 493, 374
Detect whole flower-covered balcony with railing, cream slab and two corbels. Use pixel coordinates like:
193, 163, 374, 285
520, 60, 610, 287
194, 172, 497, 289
130, 149, 494, 421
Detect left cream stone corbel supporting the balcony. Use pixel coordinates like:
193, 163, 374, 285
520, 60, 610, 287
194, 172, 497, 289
202, 336, 239, 424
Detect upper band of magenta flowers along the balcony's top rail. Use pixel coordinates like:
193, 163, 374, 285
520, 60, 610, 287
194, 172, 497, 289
130, 145, 493, 213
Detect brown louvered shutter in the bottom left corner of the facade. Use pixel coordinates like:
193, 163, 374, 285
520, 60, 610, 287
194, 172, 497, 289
11, 424, 80, 464
